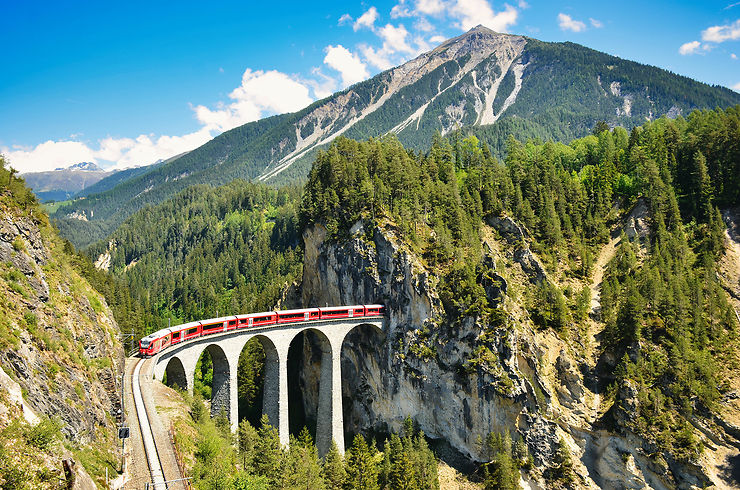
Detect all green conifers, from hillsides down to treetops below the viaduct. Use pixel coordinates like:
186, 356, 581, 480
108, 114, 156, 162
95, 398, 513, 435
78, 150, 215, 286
56, 106, 740, 488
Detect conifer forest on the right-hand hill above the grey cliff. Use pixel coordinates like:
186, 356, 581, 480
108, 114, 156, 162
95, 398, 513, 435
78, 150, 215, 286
301, 107, 740, 468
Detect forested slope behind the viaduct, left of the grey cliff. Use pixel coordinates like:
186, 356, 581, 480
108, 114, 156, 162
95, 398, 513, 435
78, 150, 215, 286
79, 180, 301, 342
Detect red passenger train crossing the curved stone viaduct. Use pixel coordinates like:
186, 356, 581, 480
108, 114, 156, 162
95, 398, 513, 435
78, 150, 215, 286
139, 305, 385, 357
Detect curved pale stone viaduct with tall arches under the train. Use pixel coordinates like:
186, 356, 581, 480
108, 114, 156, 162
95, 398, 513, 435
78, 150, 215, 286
148, 317, 383, 456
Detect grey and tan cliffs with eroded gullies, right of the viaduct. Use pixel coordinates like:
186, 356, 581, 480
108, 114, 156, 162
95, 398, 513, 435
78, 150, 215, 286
300, 215, 740, 489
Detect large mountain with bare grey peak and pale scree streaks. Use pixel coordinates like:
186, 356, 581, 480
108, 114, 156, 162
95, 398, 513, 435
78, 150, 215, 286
54, 26, 740, 246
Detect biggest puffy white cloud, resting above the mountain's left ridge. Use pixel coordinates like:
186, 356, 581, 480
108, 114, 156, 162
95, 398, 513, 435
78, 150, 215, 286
193, 68, 313, 132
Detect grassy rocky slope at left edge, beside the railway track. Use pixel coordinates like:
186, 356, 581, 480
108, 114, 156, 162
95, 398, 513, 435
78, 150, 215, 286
0, 162, 123, 488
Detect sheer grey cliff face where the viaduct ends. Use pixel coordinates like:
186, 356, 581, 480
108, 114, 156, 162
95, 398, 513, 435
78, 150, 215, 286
302, 222, 557, 463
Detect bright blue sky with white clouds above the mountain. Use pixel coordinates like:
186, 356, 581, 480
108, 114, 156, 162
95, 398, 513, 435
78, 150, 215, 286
0, 0, 740, 172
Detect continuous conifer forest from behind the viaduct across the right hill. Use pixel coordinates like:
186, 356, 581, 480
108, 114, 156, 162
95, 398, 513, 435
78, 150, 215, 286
90, 106, 740, 488
